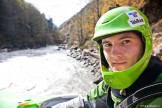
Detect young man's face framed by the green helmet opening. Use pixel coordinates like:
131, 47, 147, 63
102, 32, 144, 71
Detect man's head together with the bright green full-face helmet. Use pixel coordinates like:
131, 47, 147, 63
93, 6, 152, 89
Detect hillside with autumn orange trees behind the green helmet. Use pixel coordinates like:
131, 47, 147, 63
59, 0, 162, 57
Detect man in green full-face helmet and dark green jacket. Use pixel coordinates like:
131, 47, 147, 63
42, 6, 162, 108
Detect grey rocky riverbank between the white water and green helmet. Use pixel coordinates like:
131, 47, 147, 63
58, 45, 102, 84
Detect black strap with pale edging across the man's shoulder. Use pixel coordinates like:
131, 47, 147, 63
116, 83, 162, 108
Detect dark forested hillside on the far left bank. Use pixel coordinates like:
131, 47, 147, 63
0, 0, 61, 50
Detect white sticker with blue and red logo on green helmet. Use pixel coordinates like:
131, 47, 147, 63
126, 10, 145, 27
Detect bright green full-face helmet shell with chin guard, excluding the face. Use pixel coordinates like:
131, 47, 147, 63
92, 6, 152, 89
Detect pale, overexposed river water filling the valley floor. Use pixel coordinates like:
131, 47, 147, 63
0, 46, 95, 96
